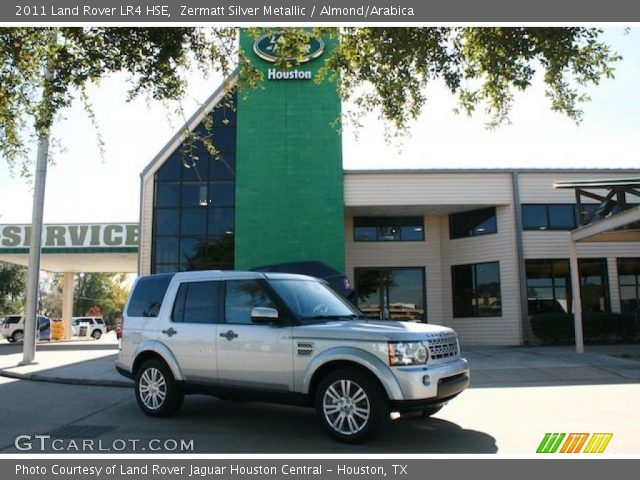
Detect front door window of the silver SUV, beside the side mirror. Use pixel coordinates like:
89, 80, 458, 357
224, 280, 276, 325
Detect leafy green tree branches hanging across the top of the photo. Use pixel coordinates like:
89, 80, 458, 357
0, 27, 620, 175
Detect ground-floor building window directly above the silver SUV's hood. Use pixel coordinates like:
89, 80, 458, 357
355, 267, 427, 322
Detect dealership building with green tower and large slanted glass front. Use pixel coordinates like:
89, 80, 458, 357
129, 34, 640, 345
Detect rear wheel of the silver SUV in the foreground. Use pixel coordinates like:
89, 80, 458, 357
135, 358, 184, 417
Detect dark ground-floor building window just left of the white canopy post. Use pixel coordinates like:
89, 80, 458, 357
525, 259, 572, 315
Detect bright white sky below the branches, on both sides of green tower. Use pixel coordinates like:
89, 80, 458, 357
0, 28, 640, 224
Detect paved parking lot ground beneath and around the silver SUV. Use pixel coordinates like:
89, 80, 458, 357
0, 338, 640, 454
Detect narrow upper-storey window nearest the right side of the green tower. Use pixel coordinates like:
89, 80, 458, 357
353, 217, 424, 242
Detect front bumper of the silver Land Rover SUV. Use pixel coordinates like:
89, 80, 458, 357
391, 358, 470, 404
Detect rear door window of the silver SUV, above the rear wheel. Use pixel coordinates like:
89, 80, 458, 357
171, 282, 222, 323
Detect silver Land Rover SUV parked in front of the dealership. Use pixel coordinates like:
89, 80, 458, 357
116, 271, 469, 443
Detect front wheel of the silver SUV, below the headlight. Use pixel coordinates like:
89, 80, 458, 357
315, 368, 389, 443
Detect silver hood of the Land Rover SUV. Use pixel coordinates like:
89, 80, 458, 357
293, 320, 455, 342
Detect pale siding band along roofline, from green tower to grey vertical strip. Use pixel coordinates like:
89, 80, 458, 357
344, 173, 512, 207
